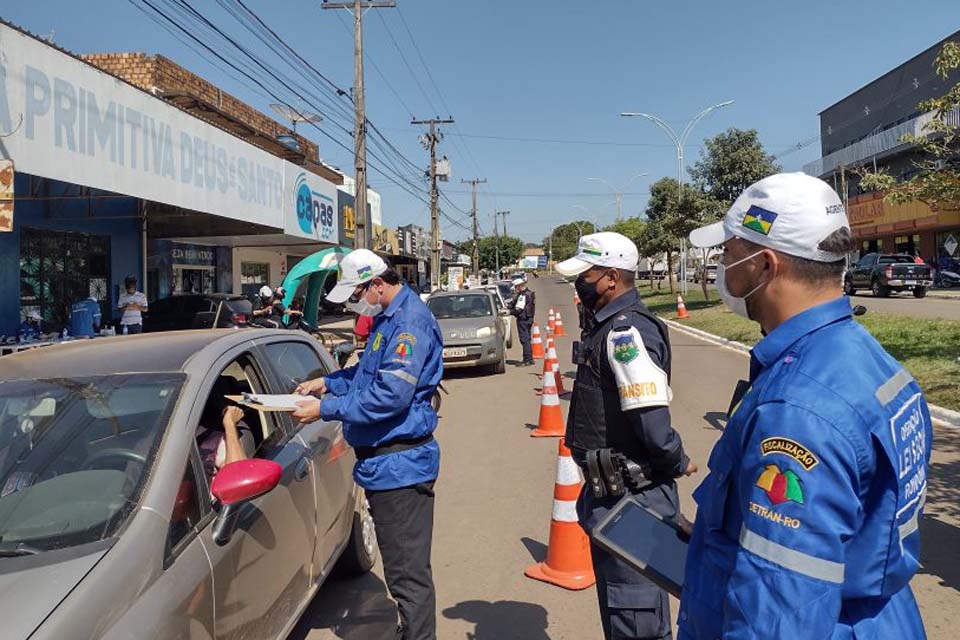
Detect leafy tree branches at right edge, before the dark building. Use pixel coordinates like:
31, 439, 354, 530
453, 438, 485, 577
860, 42, 960, 207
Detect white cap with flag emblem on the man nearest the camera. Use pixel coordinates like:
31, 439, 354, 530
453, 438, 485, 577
690, 173, 850, 262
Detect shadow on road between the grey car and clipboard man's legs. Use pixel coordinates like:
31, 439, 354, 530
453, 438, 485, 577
287, 573, 397, 640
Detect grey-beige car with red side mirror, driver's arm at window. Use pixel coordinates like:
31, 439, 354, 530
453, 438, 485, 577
0, 329, 376, 640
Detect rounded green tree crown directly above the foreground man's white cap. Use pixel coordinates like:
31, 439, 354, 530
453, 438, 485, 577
690, 127, 782, 207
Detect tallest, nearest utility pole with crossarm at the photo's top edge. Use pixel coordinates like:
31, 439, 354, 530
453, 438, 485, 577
322, 0, 397, 249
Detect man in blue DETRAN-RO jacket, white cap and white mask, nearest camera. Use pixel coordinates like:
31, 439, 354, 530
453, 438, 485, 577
679, 173, 932, 640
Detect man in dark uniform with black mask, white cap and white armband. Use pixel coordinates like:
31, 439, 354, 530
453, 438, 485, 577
556, 232, 697, 640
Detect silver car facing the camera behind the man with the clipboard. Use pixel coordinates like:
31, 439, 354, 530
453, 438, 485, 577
427, 289, 509, 373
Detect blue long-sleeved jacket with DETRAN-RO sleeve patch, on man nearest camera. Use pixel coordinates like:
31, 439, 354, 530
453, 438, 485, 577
678, 298, 932, 640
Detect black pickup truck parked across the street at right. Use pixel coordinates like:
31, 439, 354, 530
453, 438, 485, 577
843, 253, 933, 298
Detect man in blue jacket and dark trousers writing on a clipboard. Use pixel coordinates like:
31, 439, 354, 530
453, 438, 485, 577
293, 249, 443, 640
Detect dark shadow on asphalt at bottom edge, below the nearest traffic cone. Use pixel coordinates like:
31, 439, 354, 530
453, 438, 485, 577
443, 600, 550, 640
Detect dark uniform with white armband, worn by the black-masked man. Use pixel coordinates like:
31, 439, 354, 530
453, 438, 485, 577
566, 291, 689, 639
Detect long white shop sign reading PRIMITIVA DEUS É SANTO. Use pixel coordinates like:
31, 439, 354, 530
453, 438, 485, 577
0, 24, 284, 228
